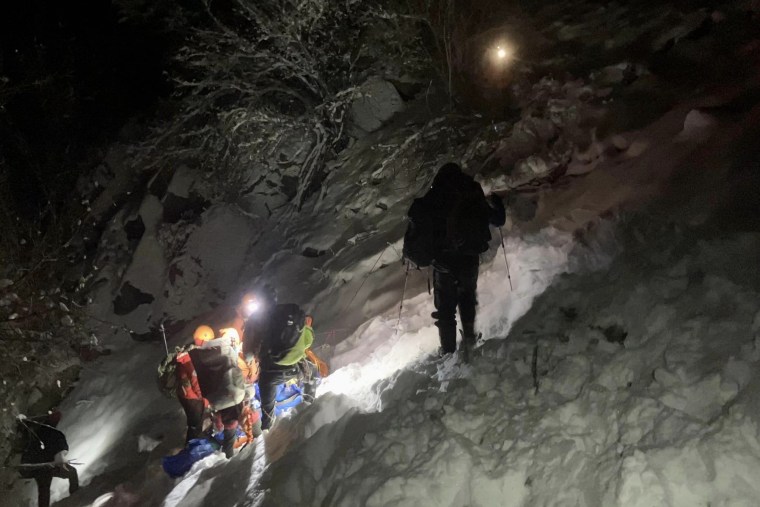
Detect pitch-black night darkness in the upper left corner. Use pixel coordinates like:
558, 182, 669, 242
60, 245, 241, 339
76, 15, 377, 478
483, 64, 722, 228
0, 0, 170, 219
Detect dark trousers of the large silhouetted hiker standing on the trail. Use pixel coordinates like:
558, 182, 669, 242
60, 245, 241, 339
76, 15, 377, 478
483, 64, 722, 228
432, 255, 480, 353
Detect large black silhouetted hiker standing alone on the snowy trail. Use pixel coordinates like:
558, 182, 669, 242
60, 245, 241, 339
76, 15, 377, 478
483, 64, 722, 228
409, 163, 506, 359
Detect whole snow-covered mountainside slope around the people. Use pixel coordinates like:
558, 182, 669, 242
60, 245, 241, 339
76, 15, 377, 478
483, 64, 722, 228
5, 0, 760, 506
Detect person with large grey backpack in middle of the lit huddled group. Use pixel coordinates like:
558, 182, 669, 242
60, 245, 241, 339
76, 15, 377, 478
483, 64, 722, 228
187, 333, 247, 458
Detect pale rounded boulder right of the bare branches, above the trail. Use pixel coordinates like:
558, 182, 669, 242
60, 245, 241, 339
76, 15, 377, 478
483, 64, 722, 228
351, 78, 404, 135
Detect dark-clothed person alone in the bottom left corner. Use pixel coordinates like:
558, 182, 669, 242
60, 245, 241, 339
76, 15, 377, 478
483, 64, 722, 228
19, 410, 79, 507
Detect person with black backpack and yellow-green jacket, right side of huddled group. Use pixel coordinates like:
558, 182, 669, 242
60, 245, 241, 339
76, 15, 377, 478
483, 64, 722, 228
245, 286, 316, 430
